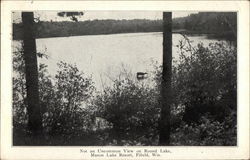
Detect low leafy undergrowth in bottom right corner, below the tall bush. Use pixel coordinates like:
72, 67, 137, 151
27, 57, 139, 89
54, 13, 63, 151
171, 111, 237, 146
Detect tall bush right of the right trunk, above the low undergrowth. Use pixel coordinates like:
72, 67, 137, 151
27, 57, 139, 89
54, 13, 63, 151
173, 43, 237, 122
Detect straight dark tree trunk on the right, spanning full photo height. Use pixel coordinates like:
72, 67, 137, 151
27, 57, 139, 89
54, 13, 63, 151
159, 12, 172, 145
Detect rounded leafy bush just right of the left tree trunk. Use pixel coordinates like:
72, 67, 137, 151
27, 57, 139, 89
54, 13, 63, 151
40, 62, 94, 137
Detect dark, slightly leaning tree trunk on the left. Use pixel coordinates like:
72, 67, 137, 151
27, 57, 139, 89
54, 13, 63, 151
22, 12, 42, 140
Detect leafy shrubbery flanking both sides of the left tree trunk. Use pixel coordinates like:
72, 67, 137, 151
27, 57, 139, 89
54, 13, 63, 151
13, 43, 94, 144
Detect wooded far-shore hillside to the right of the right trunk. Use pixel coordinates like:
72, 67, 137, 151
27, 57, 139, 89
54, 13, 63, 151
173, 12, 237, 40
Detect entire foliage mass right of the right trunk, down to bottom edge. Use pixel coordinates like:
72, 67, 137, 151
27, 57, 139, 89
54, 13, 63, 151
168, 42, 237, 145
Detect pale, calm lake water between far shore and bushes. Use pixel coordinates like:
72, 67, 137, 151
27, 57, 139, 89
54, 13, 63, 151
13, 32, 221, 90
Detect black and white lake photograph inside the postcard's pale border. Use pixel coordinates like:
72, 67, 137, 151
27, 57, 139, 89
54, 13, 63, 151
11, 10, 238, 146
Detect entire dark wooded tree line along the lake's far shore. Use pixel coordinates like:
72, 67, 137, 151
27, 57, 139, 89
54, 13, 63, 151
13, 12, 237, 40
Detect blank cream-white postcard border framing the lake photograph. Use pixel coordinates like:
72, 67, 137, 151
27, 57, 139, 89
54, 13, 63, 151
1, 1, 249, 159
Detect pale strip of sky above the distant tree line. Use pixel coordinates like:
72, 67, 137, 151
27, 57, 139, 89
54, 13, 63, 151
13, 11, 197, 23
